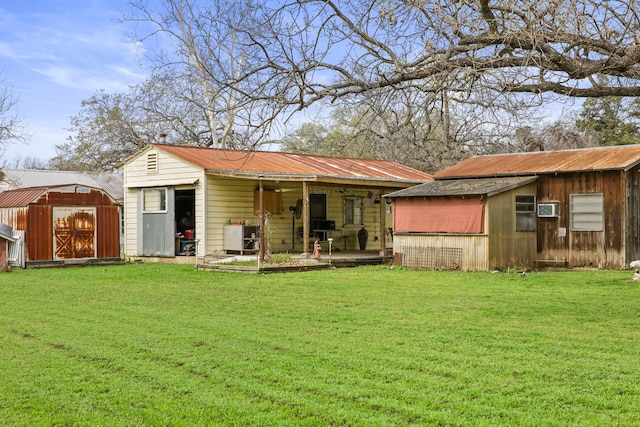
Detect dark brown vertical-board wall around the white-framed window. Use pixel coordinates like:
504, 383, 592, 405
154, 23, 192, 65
537, 171, 626, 268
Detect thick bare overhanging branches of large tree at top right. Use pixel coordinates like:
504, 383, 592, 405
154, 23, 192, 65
245, 0, 640, 107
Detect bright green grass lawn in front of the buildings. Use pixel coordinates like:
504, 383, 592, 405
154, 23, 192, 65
0, 264, 640, 426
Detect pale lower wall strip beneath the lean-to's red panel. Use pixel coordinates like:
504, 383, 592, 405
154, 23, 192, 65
393, 233, 489, 271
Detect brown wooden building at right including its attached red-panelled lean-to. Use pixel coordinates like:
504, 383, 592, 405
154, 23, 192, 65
388, 145, 640, 270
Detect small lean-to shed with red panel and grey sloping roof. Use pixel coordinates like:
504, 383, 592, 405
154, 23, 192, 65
385, 177, 537, 271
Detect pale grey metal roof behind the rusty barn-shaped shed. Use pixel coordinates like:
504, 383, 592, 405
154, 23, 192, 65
0, 169, 124, 201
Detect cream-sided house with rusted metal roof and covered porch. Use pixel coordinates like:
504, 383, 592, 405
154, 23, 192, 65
124, 144, 431, 261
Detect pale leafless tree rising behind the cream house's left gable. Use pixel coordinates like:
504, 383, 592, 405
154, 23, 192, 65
126, 0, 282, 148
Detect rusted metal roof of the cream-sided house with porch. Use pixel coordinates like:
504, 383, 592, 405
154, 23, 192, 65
152, 144, 432, 183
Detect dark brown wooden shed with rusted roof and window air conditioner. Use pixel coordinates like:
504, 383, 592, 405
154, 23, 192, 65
422, 145, 640, 269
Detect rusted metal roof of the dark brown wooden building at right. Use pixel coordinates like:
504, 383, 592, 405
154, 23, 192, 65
434, 145, 640, 179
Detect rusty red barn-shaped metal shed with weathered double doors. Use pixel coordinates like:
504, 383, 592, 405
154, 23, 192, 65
0, 184, 120, 266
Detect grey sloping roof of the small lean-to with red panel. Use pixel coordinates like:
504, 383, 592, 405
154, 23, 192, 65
384, 177, 538, 198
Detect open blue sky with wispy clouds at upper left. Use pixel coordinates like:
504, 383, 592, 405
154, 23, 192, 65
0, 0, 145, 164
